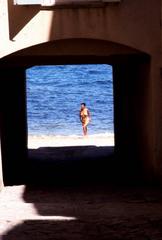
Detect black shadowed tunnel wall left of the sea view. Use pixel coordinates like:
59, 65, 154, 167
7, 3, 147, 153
0, 67, 27, 184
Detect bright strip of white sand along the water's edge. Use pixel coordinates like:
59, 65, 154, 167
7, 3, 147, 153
28, 134, 114, 149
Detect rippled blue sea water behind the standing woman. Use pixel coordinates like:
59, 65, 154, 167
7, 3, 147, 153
26, 64, 114, 135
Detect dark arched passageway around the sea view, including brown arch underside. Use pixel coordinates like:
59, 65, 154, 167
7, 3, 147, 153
1, 40, 152, 186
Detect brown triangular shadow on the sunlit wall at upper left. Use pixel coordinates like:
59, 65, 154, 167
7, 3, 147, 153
8, 0, 40, 40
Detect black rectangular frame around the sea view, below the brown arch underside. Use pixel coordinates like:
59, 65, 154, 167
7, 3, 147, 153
0, 39, 152, 184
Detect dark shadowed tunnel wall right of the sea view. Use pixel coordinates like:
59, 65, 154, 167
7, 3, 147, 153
114, 60, 154, 179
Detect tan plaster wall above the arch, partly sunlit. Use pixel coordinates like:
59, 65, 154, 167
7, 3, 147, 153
0, 0, 161, 57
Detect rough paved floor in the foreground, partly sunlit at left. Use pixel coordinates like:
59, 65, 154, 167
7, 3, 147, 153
0, 186, 162, 240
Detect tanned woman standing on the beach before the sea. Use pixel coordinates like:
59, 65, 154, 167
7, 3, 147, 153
80, 103, 90, 136
